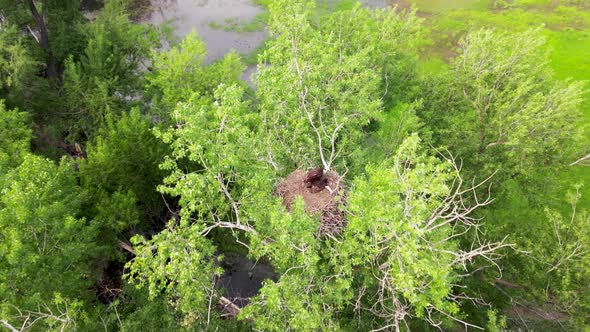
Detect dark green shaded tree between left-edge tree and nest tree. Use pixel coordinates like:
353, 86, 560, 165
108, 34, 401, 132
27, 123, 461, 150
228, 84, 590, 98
80, 109, 167, 222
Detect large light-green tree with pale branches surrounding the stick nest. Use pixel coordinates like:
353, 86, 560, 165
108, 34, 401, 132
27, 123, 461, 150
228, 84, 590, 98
127, 2, 505, 331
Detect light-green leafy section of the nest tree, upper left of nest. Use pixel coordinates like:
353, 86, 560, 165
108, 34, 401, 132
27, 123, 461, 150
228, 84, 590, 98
158, 86, 261, 221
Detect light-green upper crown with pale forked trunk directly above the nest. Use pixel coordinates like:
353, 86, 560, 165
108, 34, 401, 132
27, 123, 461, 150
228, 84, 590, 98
256, 1, 426, 174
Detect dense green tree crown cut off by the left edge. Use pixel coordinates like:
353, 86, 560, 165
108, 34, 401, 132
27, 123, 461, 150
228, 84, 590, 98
0, 155, 97, 312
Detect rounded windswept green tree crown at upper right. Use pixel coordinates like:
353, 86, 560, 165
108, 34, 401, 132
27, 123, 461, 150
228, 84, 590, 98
420, 29, 583, 180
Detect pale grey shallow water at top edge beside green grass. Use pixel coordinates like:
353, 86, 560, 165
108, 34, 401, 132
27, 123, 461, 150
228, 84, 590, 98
146, 0, 267, 63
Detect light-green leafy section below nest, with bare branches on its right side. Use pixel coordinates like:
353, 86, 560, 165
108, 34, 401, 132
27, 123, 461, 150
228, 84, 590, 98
242, 136, 510, 331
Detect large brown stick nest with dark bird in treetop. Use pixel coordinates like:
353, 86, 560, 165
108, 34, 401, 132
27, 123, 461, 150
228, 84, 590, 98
275, 169, 346, 235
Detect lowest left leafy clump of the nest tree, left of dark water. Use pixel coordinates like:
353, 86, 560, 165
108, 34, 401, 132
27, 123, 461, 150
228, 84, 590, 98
127, 221, 222, 324
